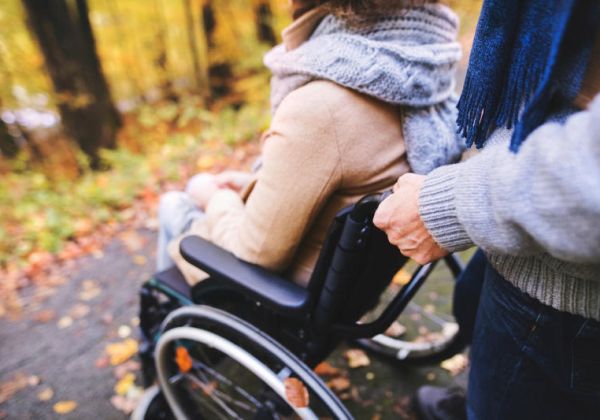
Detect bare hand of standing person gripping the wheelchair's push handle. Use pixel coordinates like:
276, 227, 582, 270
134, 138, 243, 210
373, 174, 448, 264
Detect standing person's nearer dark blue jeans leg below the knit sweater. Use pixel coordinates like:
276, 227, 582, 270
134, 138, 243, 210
467, 263, 600, 420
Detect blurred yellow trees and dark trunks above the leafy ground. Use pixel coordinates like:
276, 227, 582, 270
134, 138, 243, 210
0, 0, 287, 170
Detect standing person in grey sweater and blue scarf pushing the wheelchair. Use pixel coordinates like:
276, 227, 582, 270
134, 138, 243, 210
375, 0, 600, 420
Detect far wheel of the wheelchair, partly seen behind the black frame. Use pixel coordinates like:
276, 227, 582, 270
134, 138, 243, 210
357, 256, 467, 364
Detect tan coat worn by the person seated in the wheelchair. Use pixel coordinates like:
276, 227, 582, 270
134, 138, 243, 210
171, 81, 409, 284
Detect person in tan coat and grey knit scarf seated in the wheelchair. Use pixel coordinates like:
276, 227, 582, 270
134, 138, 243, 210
158, 0, 462, 285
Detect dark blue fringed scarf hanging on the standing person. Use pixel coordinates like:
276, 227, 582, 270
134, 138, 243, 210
457, 0, 600, 152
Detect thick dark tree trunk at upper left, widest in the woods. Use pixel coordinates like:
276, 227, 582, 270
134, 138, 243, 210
23, 0, 120, 169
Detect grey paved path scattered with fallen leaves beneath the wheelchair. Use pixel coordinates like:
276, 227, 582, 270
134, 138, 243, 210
0, 230, 464, 419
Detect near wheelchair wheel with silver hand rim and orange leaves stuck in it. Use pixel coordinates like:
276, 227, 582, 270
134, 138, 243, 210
155, 306, 351, 419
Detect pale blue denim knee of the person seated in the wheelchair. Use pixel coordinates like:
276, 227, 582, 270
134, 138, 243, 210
156, 191, 204, 271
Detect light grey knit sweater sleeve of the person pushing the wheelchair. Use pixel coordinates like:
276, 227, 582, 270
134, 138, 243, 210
419, 95, 600, 264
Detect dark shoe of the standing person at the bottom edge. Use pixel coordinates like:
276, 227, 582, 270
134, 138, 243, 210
414, 385, 467, 420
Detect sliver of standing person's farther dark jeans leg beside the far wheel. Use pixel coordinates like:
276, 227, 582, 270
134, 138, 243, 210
452, 249, 487, 344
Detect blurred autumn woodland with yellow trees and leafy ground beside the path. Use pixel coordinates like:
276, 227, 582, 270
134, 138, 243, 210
0, 0, 481, 272
